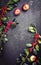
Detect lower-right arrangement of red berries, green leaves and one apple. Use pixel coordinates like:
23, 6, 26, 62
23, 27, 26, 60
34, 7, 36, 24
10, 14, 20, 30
17, 24, 41, 65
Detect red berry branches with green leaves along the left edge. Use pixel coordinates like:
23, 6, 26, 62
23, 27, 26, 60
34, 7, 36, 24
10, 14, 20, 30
0, 0, 18, 54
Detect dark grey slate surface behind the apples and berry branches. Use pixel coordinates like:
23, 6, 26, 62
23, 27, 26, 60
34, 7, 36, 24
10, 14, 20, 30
0, 0, 41, 65
